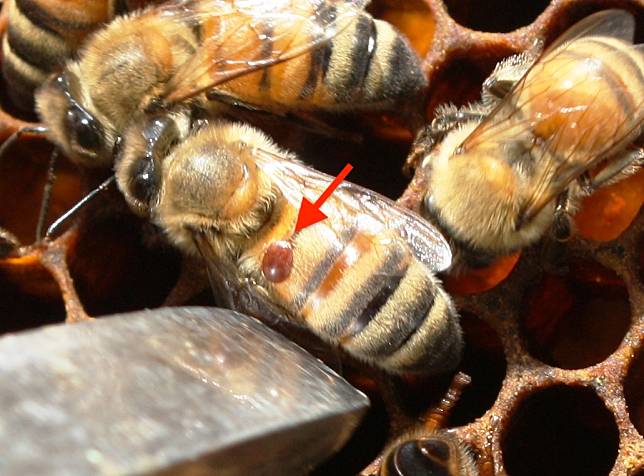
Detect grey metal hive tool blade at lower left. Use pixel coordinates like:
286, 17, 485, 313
0, 307, 368, 476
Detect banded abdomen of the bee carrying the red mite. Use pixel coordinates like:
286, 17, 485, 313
280, 230, 461, 373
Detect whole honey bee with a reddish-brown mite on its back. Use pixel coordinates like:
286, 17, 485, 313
116, 121, 462, 373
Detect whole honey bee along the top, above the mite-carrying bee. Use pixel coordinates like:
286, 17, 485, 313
36, 0, 426, 167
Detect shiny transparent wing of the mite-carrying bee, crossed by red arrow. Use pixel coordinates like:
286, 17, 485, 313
253, 148, 452, 272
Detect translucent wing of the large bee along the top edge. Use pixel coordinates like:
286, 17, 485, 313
149, 0, 368, 103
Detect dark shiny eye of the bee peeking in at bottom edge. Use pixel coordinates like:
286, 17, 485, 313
380, 438, 451, 476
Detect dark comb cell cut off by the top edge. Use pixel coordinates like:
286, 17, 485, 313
445, 0, 550, 33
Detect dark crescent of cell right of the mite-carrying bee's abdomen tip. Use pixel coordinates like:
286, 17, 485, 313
447, 313, 506, 427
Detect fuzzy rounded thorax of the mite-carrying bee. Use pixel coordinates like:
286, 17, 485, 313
152, 122, 284, 254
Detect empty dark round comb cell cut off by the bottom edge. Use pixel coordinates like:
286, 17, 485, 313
501, 385, 619, 476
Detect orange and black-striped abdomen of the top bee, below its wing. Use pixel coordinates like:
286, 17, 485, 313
213, 3, 426, 111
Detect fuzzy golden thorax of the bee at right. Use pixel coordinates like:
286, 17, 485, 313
426, 122, 552, 254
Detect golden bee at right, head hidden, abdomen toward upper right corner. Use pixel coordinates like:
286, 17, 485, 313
421, 10, 644, 264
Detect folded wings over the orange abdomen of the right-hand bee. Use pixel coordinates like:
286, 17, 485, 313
461, 10, 644, 219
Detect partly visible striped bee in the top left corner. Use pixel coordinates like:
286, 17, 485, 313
2, 0, 151, 111
